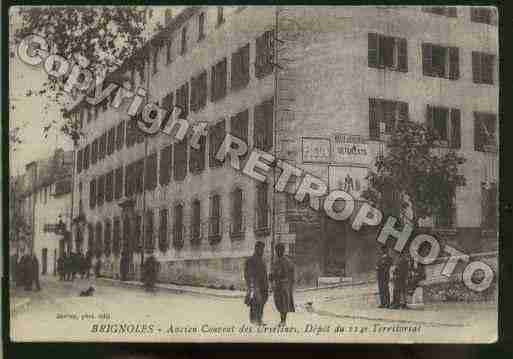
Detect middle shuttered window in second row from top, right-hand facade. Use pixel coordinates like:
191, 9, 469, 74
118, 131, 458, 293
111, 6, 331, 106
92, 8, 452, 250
422, 43, 460, 80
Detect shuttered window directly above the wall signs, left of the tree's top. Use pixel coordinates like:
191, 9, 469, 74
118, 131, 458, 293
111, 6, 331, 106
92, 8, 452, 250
369, 98, 408, 140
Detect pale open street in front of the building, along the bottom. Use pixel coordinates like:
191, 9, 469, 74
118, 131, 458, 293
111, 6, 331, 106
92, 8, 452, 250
11, 277, 497, 343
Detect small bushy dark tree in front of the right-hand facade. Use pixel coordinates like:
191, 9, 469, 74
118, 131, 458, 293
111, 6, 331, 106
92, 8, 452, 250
362, 120, 465, 226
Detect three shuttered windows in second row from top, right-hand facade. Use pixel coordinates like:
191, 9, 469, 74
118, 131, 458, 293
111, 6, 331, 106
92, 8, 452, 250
368, 33, 496, 85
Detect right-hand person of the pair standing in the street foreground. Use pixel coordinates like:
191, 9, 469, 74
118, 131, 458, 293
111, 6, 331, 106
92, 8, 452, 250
270, 243, 295, 326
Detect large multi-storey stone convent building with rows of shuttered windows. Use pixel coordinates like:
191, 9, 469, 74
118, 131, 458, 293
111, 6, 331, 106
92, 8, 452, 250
67, 6, 498, 287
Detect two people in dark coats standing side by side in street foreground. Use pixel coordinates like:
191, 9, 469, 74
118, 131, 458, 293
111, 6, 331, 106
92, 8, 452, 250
244, 241, 295, 326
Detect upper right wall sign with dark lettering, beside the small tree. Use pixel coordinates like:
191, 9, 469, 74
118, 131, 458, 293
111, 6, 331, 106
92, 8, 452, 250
331, 134, 370, 165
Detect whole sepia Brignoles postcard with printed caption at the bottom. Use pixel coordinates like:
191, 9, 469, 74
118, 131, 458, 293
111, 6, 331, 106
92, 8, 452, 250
8, 6, 499, 343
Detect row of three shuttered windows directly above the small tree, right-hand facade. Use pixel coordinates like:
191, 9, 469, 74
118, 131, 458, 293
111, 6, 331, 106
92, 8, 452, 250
369, 98, 497, 152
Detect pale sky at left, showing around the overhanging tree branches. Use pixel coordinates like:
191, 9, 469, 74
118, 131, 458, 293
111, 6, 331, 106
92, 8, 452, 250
9, 7, 183, 175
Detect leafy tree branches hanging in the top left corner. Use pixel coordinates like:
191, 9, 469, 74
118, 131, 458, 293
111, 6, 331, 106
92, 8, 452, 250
11, 6, 156, 140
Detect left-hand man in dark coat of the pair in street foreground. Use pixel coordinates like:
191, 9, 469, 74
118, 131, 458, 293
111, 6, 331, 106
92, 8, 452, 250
244, 241, 269, 325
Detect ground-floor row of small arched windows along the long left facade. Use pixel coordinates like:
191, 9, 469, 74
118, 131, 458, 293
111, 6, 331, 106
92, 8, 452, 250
84, 183, 270, 257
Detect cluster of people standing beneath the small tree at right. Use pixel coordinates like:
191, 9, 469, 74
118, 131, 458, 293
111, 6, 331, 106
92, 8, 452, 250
376, 246, 426, 309
